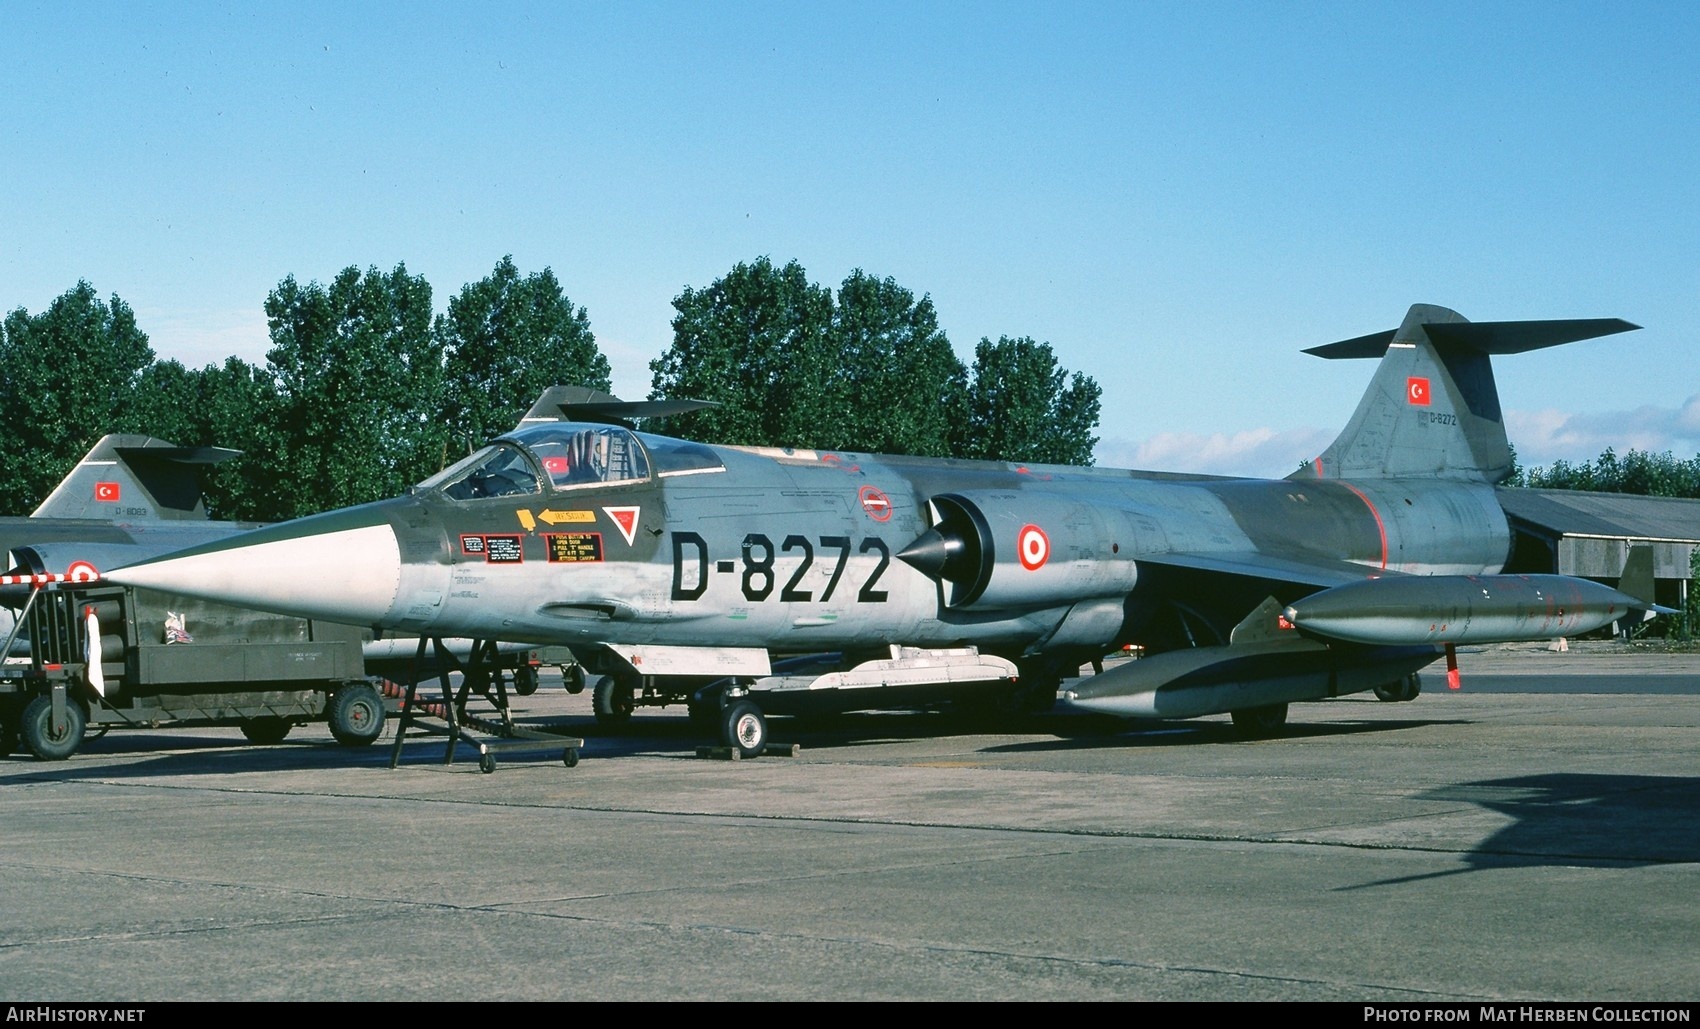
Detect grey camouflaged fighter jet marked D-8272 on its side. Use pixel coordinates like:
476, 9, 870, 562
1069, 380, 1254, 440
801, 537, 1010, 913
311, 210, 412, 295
107, 304, 1652, 755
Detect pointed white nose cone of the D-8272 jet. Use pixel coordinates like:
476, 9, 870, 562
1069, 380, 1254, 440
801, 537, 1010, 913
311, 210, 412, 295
105, 503, 401, 626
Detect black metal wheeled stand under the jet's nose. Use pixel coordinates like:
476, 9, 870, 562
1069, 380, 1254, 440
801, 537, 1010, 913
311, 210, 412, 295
386, 638, 585, 776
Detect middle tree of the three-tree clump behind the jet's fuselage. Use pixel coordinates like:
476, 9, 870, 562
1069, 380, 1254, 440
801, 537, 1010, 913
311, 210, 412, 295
828, 269, 967, 458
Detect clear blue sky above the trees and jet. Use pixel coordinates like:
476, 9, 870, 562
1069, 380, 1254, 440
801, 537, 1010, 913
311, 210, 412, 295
0, 0, 1700, 475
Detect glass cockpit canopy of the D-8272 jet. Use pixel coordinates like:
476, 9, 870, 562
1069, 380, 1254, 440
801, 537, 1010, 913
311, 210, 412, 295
418, 422, 724, 500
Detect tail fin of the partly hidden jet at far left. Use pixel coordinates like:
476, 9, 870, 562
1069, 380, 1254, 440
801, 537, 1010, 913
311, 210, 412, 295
31, 432, 241, 520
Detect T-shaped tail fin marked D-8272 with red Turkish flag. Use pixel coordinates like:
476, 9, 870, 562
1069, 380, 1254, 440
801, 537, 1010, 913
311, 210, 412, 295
1289, 304, 1641, 483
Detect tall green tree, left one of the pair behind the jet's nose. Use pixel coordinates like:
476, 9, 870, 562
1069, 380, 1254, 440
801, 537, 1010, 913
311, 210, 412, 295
258, 264, 447, 519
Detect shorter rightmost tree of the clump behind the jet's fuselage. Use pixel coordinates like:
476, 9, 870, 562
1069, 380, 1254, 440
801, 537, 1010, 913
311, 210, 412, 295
959, 337, 1102, 464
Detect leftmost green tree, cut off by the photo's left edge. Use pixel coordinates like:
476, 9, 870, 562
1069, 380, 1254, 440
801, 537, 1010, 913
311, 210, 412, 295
0, 282, 153, 514
